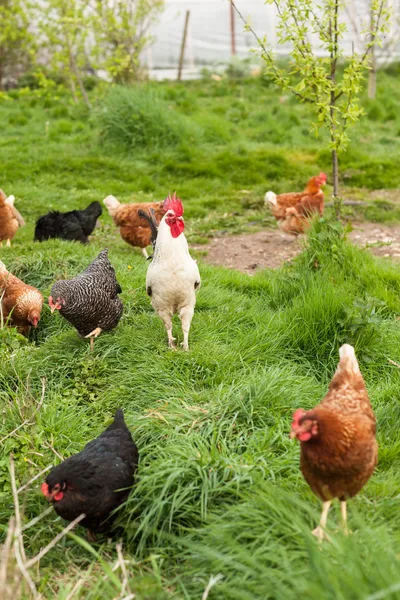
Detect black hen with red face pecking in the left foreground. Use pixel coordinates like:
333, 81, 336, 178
41, 409, 139, 541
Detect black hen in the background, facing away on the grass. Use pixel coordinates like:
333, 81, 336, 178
34, 202, 103, 244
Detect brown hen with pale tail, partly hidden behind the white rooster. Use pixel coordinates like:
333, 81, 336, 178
103, 196, 165, 258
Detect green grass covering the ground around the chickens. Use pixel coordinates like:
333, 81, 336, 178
0, 75, 400, 600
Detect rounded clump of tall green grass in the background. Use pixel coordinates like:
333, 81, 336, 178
97, 86, 202, 150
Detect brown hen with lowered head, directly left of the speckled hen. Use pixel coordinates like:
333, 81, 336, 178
0, 261, 43, 334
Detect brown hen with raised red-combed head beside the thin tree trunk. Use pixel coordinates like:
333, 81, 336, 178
265, 173, 326, 235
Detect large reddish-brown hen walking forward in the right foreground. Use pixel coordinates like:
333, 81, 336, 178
290, 344, 378, 540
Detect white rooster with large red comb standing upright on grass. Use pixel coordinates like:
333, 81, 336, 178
146, 194, 201, 350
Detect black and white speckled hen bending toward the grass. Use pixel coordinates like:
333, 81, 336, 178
49, 248, 123, 349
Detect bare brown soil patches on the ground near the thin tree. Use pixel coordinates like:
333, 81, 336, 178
192, 223, 400, 275
